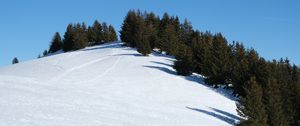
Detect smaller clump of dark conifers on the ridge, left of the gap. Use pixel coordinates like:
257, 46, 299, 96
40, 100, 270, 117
43, 20, 118, 56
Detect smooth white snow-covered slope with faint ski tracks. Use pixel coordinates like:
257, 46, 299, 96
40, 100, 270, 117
0, 42, 239, 126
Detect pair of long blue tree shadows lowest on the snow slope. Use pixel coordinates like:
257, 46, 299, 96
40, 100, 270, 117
186, 107, 236, 125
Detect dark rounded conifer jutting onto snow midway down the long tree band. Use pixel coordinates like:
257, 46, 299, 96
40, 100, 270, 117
173, 44, 194, 76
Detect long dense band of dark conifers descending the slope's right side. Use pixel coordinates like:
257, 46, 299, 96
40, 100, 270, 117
120, 10, 300, 126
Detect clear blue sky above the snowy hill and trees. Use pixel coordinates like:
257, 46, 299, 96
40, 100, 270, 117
0, 0, 300, 67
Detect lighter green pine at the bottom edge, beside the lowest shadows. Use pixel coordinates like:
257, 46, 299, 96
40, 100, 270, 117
237, 77, 268, 126
